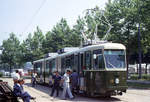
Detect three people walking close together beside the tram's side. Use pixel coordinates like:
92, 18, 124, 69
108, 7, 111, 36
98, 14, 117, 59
50, 70, 78, 99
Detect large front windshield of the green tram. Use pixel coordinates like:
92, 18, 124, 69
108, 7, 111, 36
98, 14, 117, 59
104, 50, 125, 68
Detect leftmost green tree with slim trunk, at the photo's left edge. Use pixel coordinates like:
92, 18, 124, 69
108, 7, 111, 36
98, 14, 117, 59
1, 33, 20, 73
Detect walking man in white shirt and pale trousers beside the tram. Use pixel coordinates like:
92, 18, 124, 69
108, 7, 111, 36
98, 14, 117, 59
62, 70, 74, 99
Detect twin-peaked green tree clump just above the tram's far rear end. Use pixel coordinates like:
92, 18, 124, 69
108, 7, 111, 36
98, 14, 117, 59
20, 27, 44, 63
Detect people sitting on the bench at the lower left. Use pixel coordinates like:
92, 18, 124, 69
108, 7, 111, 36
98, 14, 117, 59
13, 70, 35, 102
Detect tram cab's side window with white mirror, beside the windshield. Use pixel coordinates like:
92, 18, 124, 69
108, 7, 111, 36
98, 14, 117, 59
93, 49, 104, 69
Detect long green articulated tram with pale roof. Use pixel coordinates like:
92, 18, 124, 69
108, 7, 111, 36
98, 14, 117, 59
33, 42, 127, 96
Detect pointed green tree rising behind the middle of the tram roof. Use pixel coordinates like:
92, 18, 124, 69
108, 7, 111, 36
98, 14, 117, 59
45, 18, 71, 52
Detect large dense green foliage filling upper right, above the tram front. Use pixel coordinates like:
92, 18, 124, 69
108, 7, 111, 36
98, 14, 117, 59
105, 0, 150, 63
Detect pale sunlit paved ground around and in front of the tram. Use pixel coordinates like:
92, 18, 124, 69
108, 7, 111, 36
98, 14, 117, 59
0, 78, 150, 102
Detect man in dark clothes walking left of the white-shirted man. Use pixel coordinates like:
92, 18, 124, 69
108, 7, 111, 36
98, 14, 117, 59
51, 71, 61, 97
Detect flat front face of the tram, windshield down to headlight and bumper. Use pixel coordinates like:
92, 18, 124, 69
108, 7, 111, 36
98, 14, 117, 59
104, 49, 127, 95
